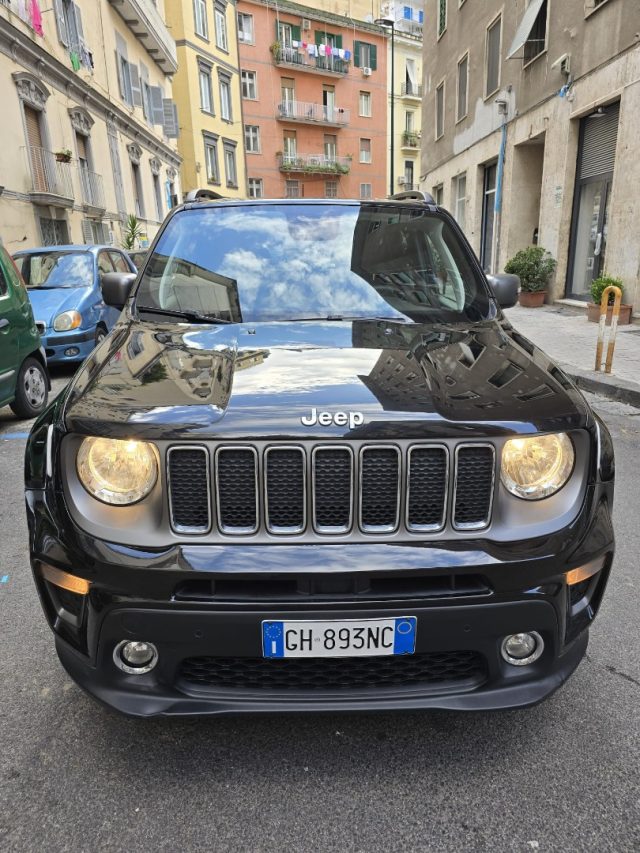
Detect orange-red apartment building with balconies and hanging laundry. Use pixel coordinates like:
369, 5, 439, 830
237, 0, 387, 198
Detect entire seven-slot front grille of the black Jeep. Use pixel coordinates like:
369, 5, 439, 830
167, 442, 495, 537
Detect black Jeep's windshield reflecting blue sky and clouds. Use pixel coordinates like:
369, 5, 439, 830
136, 204, 495, 323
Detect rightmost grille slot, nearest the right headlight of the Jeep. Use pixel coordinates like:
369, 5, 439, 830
453, 444, 495, 530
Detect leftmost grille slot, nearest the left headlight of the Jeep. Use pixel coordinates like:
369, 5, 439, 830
167, 447, 211, 533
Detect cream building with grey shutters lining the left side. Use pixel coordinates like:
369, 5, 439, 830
0, 0, 181, 251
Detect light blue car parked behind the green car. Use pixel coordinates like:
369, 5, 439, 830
14, 246, 136, 364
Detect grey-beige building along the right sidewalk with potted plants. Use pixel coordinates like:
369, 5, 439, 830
421, 0, 640, 306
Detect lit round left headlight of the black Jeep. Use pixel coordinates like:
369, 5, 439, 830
76, 438, 158, 506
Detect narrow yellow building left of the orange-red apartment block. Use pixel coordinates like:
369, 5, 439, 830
165, 0, 247, 198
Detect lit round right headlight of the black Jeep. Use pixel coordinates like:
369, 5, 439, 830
500, 432, 576, 501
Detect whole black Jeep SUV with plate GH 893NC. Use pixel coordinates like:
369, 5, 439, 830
26, 199, 614, 715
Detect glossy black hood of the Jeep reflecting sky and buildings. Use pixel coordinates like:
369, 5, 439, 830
65, 319, 589, 439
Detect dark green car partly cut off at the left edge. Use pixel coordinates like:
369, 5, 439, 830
0, 241, 51, 418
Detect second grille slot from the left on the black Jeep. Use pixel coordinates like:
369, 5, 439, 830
216, 447, 258, 534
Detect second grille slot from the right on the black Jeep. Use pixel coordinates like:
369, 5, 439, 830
407, 447, 449, 531
